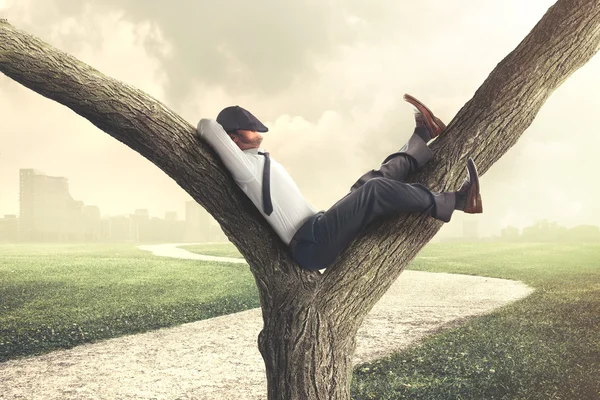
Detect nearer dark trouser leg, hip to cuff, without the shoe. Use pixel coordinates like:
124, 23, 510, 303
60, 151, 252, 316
294, 178, 454, 269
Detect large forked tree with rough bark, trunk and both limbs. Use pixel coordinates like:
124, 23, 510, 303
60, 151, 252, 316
0, 0, 600, 399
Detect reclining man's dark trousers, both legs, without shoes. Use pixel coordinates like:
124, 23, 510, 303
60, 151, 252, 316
290, 135, 454, 270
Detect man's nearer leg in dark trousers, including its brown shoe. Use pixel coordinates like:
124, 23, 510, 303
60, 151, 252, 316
290, 158, 483, 270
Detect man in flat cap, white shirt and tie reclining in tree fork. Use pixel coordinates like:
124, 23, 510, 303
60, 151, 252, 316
198, 95, 483, 270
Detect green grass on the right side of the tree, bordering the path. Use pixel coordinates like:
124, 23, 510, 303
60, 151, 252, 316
352, 243, 600, 400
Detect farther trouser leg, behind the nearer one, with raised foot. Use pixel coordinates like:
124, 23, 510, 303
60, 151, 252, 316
350, 134, 433, 192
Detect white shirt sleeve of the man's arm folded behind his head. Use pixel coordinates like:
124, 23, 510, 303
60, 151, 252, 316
198, 118, 254, 182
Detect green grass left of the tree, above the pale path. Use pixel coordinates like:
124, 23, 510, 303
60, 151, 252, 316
0, 244, 260, 361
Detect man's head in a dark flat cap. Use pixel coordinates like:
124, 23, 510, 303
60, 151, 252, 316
217, 106, 269, 150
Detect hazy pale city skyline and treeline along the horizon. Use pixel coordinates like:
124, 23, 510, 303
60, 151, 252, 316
0, 168, 600, 242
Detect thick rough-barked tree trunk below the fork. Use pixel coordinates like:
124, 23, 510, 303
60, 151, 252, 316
258, 305, 356, 400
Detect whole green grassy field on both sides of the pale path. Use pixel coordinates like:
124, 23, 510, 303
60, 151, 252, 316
0, 243, 600, 400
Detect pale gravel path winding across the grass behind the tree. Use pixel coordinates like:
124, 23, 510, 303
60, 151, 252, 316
0, 244, 532, 400
